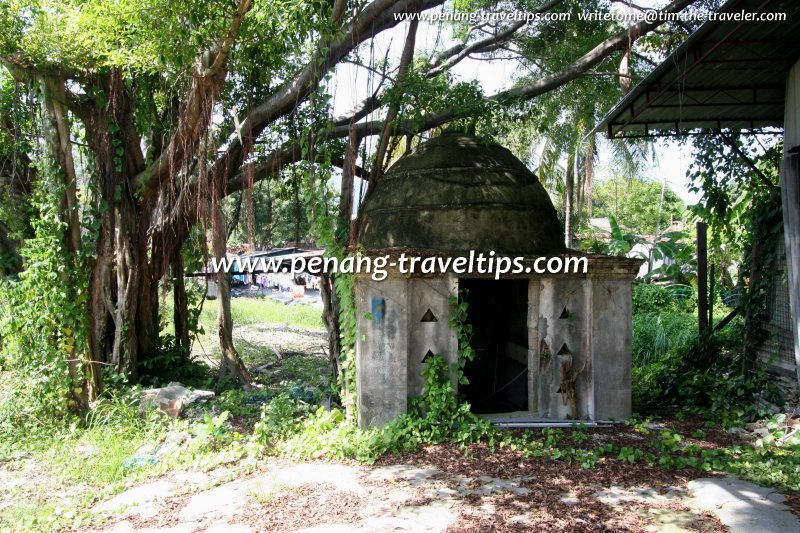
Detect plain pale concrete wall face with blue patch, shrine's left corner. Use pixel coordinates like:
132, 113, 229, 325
356, 278, 410, 428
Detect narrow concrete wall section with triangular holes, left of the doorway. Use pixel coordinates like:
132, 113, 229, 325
410, 276, 458, 398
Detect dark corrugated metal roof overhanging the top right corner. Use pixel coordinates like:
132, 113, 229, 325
595, 0, 800, 138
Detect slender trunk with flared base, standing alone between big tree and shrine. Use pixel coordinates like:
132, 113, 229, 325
211, 206, 253, 387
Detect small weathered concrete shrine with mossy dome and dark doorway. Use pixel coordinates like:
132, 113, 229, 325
356, 133, 640, 427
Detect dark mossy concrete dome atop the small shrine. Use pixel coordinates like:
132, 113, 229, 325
358, 133, 565, 255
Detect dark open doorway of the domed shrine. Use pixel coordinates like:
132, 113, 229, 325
459, 279, 528, 414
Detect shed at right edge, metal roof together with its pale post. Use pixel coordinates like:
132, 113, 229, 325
595, 0, 800, 383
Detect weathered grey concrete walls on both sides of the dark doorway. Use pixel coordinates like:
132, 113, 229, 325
356, 268, 632, 428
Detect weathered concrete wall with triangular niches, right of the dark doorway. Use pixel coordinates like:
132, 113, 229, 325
529, 278, 632, 420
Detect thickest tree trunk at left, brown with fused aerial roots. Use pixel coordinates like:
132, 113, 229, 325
75, 71, 166, 378
